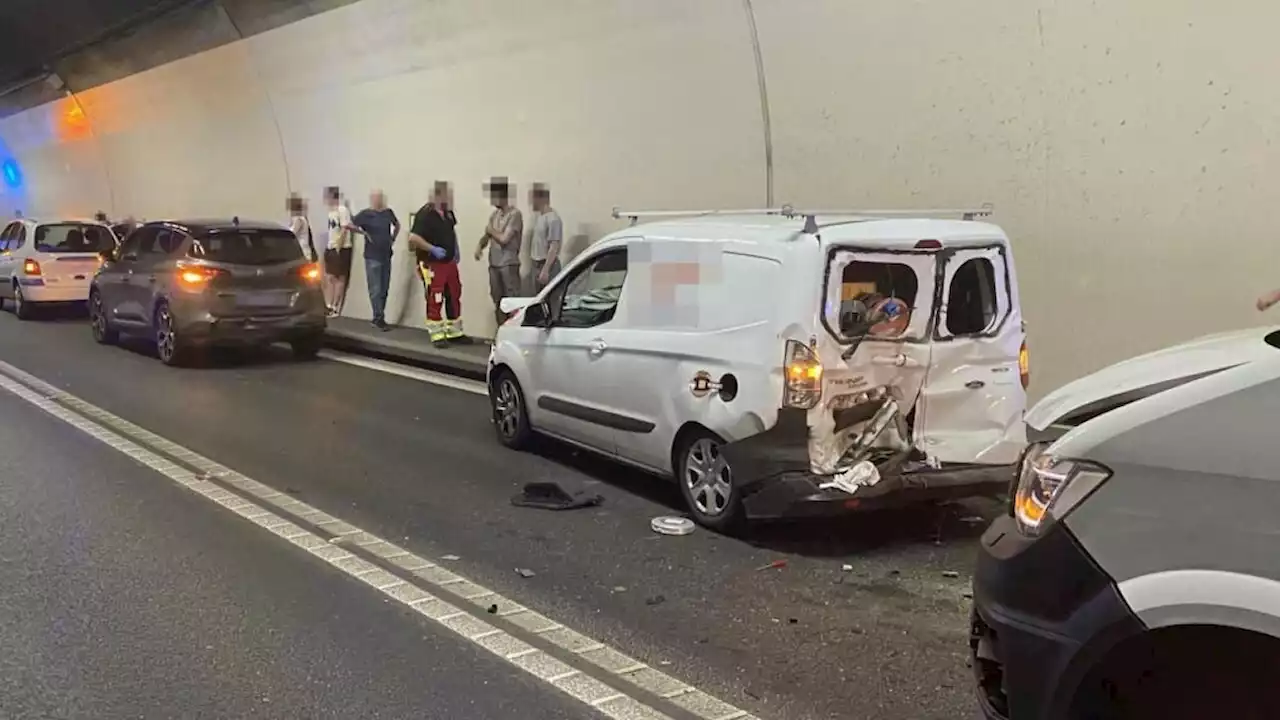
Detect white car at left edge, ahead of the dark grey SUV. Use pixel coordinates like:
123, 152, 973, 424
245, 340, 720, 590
0, 218, 116, 320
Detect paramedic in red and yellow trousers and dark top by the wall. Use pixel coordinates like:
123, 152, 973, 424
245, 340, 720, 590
408, 181, 465, 343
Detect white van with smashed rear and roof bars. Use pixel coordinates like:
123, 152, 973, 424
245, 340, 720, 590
489, 208, 1027, 529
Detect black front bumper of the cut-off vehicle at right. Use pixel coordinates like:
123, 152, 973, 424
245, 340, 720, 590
969, 515, 1143, 720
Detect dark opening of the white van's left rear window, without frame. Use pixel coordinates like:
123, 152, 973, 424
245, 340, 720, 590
840, 260, 920, 338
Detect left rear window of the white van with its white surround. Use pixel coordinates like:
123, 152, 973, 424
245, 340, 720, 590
823, 250, 936, 342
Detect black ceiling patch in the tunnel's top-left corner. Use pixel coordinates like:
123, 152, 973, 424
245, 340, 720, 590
0, 0, 183, 88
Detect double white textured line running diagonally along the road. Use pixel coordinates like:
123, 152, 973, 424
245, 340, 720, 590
0, 361, 758, 720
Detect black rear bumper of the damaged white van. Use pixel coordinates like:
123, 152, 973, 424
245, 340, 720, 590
721, 409, 1014, 520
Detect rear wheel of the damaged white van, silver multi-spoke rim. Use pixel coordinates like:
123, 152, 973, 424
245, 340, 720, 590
676, 430, 742, 533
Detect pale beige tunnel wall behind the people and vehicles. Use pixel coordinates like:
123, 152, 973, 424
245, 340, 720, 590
0, 0, 1280, 393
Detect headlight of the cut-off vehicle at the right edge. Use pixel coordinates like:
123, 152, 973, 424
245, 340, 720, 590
1010, 443, 1111, 537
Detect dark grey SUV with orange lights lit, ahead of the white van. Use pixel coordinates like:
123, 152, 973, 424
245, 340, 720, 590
88, 219, 325, 365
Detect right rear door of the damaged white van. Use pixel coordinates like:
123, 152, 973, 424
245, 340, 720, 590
919, 245, 1027, 464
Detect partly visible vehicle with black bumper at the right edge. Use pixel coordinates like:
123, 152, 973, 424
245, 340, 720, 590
970, 328, 1280, 720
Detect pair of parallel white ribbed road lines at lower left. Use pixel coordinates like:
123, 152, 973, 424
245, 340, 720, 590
0, 360, 757, 720
